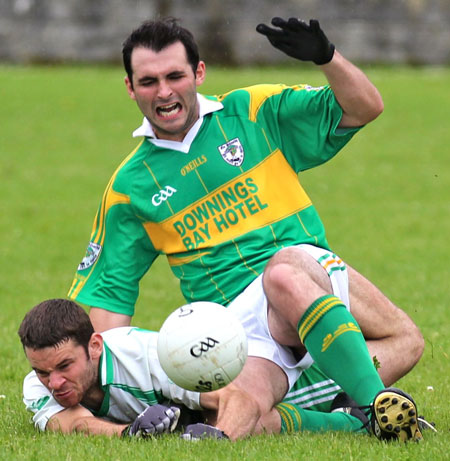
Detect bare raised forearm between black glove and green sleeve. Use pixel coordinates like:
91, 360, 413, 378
321, 51, 383, 127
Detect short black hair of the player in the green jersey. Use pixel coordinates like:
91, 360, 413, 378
122, 18, 200, 83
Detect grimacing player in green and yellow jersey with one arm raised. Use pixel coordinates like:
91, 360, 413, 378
69, 18, 423, 438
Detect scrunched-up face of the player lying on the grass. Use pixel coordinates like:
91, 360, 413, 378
25, 333, 103, 408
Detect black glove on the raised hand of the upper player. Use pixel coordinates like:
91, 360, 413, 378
256, 18, 334, 65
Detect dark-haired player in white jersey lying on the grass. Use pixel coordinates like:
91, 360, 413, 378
19, 299, 436, 439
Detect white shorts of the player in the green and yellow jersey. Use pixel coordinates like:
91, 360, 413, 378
228, 244, 350, 389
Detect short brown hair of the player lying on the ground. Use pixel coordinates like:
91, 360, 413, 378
18, 299, 94, 357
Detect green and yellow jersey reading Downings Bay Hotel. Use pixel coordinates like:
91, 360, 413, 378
69, 85, 357, 315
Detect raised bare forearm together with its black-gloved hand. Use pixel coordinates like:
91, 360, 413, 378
256, 18, 383, 127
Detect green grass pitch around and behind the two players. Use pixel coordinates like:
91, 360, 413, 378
0, 66, 450, 461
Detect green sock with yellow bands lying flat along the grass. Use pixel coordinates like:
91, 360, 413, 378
275, 402, 367, 434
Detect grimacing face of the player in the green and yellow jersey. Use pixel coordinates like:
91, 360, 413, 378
125, 42, 205, 141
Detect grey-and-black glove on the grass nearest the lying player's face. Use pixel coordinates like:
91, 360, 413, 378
122, 404, 180, 437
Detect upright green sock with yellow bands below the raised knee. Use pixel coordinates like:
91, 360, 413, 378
297, 295, 384, 405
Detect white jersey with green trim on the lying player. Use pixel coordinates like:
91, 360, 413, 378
23, 327, 201, 431
